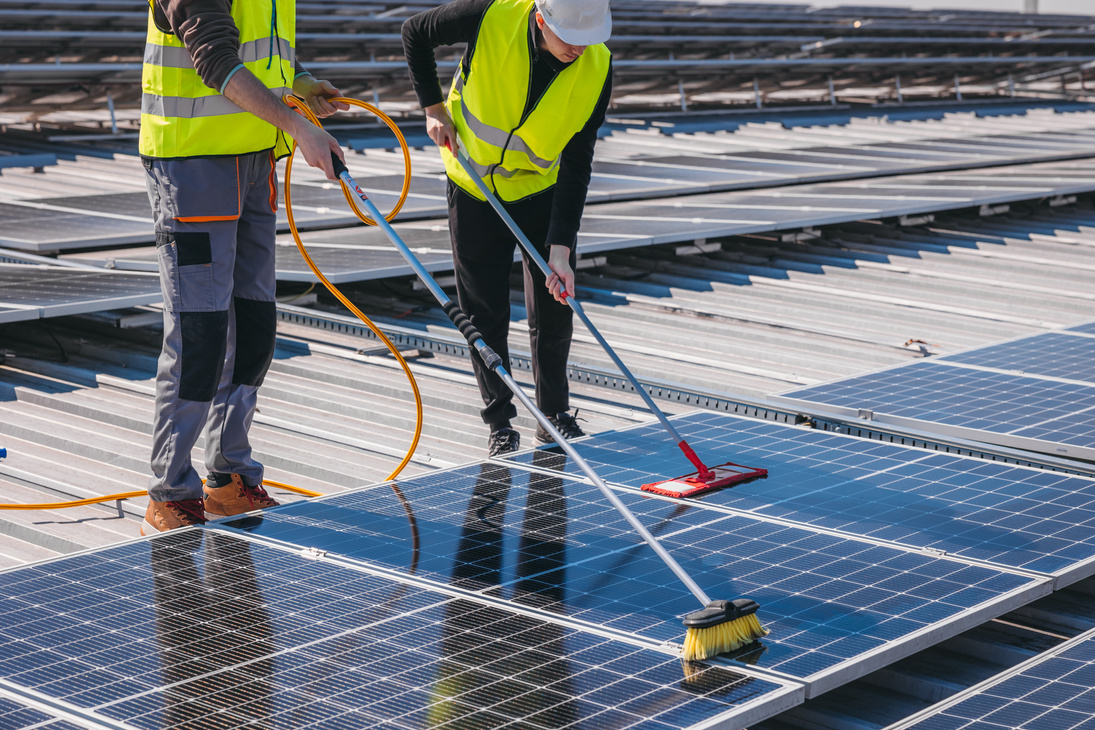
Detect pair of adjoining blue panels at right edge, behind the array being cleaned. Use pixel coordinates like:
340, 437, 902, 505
780, 325, 1095, 459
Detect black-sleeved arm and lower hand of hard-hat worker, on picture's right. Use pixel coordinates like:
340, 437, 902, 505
546, 67, 612, 301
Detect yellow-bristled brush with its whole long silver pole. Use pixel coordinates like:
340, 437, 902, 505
331, 153, 768, 661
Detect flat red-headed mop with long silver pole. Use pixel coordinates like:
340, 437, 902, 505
454, 147, 768, 497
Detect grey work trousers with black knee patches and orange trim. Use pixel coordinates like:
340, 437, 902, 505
145, 152, 277, 501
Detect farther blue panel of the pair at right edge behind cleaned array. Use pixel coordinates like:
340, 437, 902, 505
937, 332, 1095, 383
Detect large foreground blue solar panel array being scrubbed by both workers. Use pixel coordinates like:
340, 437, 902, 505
6, 367, 1095, 730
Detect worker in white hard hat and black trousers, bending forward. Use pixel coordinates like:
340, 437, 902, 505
403, 0, 612, 456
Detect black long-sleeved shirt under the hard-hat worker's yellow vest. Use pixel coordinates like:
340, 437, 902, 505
403, 0, 612, 248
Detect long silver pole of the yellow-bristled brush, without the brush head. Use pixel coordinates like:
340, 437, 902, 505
331, 153, 711, 605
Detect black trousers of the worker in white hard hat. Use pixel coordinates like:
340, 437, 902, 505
448, 181, 577, 429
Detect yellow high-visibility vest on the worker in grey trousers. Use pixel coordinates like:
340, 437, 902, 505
140, 0, 297, 159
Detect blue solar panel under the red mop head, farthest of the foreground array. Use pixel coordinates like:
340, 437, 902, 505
501, 413, 1095, 581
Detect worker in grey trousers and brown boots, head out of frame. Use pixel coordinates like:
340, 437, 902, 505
140, 0, 348, 535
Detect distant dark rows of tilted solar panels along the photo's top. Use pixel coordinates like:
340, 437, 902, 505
0, 0, 1093, 108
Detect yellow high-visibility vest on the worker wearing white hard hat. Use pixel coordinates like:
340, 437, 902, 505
441, 0, 612, 202
